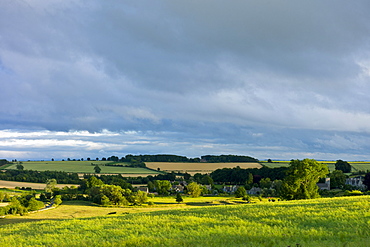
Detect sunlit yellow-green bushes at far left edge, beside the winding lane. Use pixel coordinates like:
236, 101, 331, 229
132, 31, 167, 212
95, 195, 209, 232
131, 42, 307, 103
0, 192, 44, 216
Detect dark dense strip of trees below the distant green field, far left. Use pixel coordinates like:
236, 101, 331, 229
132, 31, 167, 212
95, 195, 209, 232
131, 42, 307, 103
0, 170, 80, 184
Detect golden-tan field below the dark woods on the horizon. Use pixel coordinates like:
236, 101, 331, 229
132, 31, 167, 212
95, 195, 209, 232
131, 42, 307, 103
145, 162, 262, 175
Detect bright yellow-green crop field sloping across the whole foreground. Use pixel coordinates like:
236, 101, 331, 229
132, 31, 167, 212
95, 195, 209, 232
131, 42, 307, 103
0, 196, 370, 247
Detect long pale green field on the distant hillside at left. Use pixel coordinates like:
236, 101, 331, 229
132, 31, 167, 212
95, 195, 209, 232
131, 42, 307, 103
6, 161, 158, 175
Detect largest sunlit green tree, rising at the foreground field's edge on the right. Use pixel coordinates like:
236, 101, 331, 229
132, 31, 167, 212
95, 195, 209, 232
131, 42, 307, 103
280, 159, 329, 200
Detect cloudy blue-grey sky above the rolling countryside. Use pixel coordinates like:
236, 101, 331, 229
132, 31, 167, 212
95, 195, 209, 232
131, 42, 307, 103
0, 0, 370, 161
